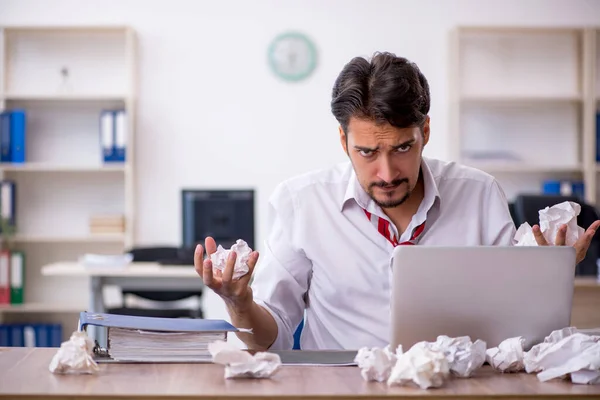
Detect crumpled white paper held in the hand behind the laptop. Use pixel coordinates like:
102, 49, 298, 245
514, 201, 585, 246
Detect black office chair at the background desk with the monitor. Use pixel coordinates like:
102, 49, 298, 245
107, 247, 203, 318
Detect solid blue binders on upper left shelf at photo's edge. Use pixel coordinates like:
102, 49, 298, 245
0, 109, 27, 163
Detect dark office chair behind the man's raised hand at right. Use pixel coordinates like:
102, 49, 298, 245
514, 194, 600, 276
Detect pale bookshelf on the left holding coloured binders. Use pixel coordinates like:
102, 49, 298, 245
0, 26, 137, 339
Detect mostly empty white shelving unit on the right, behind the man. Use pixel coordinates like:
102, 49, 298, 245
449, 27, 600, 204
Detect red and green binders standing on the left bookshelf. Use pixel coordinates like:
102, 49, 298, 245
0, 250, 25, 305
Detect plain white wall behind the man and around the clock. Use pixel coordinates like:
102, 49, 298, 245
0, 0, 600, 322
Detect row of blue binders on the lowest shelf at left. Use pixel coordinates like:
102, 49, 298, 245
0, 324, 62, 347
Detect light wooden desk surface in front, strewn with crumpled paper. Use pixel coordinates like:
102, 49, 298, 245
0, 348, 600, 400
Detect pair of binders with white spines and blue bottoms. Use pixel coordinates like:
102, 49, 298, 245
100, 110, 128, 163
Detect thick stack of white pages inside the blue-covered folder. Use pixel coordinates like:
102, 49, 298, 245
108, 328, 227, 362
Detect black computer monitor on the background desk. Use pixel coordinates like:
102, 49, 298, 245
181, 189, 255, 249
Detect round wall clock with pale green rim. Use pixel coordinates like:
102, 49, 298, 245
269, 32, 317, 82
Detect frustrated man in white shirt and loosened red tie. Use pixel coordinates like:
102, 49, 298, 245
195, 53, 599, 350
